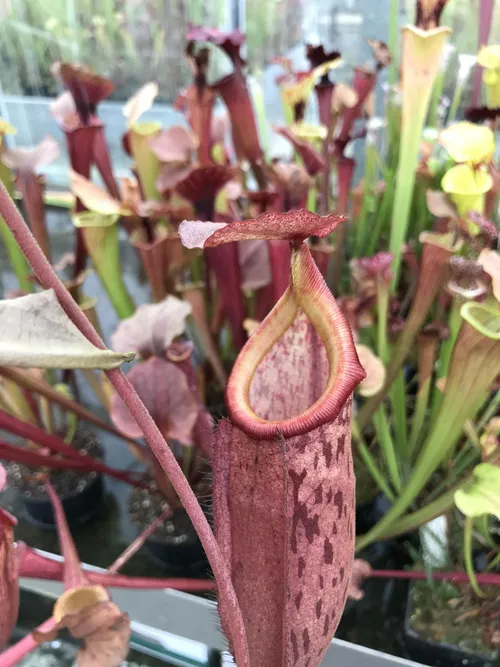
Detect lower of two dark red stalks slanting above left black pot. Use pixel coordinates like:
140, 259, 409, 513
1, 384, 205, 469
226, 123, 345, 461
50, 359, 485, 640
0, 440, 148, 489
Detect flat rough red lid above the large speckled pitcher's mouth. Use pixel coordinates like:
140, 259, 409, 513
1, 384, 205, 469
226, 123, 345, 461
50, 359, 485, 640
205, 209, 345, 248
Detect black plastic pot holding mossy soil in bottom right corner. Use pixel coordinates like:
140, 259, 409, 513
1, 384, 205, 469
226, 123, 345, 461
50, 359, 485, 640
405, 586, 500, 667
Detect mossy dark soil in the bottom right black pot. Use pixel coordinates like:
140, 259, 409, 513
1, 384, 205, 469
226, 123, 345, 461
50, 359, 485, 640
409, 581, 500, 658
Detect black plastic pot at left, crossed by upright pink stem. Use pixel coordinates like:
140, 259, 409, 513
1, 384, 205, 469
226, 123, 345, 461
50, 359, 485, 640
19, 474, 104, 530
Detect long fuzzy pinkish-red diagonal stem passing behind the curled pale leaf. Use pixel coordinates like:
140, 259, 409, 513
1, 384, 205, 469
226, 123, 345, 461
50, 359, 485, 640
0, 183, 250, 667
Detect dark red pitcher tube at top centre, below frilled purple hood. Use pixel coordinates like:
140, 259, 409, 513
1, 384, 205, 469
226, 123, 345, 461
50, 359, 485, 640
213, 70, 262, 164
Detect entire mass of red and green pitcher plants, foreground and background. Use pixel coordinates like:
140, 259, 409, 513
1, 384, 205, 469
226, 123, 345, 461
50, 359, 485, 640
0, 0, 500, 667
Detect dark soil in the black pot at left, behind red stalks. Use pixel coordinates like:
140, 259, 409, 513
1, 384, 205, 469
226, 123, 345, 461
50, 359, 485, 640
3, 426, 103, 500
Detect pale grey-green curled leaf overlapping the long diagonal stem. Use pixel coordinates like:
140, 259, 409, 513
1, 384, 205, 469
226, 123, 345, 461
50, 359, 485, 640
0, 289, 134, 369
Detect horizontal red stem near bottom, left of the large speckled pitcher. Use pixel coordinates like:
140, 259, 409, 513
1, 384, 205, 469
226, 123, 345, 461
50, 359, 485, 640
19, 547, 216, 592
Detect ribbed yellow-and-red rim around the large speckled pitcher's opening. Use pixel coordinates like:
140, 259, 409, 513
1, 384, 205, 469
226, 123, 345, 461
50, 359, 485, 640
226, 243, 365, 440
